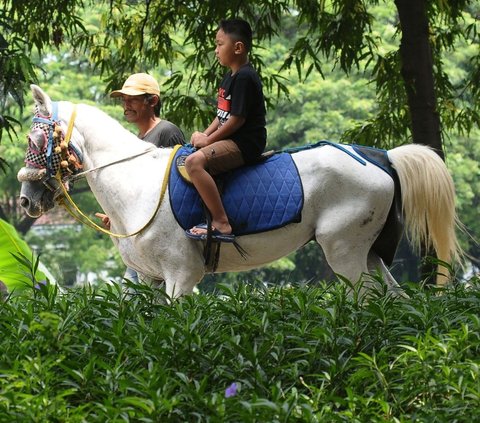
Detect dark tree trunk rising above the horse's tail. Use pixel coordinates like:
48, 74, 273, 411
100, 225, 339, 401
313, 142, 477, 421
395, 0, 444, 159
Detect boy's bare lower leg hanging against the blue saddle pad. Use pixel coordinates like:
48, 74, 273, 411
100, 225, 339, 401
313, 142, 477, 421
185, 151, 232, 235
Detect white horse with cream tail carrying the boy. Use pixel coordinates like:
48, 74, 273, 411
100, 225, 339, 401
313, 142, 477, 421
18, 85, 461, 298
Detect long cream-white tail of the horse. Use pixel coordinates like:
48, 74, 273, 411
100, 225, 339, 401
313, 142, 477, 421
388, 144, 463, 285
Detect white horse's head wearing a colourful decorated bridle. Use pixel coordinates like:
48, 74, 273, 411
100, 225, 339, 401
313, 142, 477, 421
17, 85, 81, 217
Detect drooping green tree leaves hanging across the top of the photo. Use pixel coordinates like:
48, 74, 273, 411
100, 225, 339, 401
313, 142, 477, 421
0, 0, 479, 145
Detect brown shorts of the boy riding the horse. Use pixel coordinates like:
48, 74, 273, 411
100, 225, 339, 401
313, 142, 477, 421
200, 140, 245, 175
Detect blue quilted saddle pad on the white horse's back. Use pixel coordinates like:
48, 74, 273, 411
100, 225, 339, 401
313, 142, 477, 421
169, 147, 303, 235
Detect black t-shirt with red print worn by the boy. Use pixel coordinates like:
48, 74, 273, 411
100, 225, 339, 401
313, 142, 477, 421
217, 63, 267, 163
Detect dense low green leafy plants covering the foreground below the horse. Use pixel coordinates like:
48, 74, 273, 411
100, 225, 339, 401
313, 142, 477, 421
0, 281, 480, 422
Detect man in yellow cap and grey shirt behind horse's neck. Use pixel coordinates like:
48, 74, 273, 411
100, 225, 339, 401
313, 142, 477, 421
110, 73, 185, 147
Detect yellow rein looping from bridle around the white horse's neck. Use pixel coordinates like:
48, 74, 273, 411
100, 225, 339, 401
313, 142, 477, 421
55, 105, 181, 238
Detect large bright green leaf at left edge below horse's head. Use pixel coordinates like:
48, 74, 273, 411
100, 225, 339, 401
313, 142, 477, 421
0, 219, 47, 291
